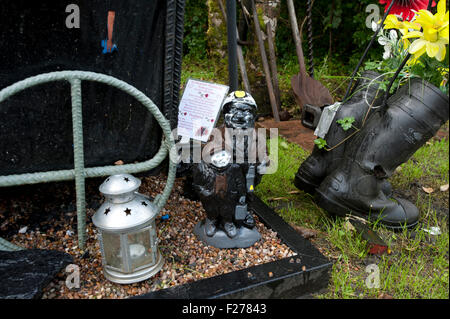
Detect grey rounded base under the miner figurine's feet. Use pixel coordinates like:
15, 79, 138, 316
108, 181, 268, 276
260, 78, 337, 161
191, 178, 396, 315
194, 220, 261, 248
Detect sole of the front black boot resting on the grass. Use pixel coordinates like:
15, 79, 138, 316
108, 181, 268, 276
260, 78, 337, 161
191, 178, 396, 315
315, 190, 419, 230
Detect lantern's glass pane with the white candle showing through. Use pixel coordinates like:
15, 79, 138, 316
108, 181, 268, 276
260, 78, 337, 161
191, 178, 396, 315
128, 228, 154, 270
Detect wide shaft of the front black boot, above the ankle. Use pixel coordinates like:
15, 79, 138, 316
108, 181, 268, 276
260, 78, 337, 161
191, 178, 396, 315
345, 79, 449, 178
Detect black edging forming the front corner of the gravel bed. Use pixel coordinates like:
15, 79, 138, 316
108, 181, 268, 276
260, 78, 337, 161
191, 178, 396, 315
133, 196, 332, 299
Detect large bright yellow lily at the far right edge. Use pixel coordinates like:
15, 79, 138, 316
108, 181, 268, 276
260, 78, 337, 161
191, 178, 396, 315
403, 0, 449, 61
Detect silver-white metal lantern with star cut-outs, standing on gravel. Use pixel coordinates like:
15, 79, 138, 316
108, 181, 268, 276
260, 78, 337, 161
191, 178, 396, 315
92, 174, 164, 284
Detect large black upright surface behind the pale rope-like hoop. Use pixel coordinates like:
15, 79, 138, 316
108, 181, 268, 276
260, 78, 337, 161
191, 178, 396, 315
0, 0, 184, 175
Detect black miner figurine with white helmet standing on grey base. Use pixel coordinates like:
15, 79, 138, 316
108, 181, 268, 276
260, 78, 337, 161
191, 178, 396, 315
192, 91, 269, 248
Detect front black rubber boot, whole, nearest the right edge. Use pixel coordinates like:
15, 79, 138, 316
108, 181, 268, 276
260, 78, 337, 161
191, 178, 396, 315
316, 79, 449, 229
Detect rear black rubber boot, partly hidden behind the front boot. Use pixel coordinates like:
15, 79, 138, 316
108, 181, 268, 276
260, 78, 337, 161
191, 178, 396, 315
294, 71, 391, 194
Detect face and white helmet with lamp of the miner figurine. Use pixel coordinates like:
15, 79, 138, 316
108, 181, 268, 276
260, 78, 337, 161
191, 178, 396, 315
222, 91, 257, 129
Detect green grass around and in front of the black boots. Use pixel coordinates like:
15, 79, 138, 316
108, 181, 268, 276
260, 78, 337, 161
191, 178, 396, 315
256, 138, 449, 298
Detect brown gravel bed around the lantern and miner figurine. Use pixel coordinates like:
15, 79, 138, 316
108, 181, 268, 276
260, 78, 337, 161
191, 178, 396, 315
0, 176, 295, 299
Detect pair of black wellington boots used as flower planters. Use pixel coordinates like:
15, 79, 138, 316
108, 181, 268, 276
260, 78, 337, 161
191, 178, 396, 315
294, 74, 449, 229
